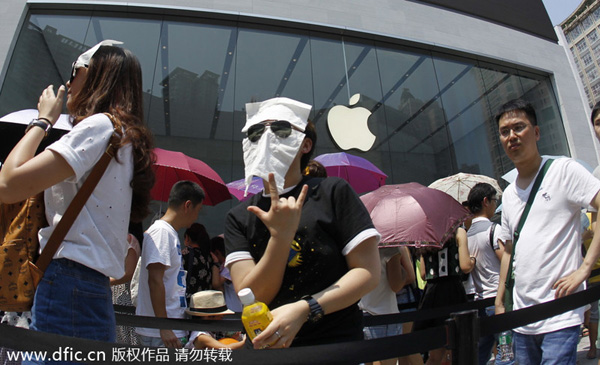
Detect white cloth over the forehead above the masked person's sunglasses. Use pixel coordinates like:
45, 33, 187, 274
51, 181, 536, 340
242, 98, 312, 133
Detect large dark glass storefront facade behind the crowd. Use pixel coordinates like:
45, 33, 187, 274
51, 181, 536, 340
0, 10, 569, 235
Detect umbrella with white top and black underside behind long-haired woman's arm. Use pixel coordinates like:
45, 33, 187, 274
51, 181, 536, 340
0, 109, 72, 162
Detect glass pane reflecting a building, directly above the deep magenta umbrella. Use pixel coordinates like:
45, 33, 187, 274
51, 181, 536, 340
149, 21, 237, 144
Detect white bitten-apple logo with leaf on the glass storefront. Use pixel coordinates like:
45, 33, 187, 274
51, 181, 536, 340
327, 94, 377, 152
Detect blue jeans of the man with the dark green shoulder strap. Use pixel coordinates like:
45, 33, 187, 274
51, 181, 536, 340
513, 326, 579, 365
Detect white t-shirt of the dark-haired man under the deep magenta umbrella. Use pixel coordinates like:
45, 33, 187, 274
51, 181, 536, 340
135, 219, 187, 338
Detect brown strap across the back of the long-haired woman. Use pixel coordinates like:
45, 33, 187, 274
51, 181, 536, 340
35, 113, 120, 272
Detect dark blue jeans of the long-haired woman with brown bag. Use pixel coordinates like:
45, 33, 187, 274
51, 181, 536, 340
30, 259, 116, 342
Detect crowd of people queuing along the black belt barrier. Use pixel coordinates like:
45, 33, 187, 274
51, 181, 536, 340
0, 41, 600, 364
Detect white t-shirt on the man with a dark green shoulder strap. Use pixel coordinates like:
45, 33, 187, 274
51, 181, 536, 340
501, 158, 600, 334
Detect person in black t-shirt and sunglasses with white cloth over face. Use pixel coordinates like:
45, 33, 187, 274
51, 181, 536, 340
225, 98, 380, 348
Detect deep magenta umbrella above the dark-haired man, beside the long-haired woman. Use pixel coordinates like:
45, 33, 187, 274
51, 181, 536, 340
151, 148, 231, 205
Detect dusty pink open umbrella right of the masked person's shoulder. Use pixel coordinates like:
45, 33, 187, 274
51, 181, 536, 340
360, 183, 469, 247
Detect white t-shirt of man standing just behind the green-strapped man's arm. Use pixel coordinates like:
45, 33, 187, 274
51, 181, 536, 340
467, 217, 501, 300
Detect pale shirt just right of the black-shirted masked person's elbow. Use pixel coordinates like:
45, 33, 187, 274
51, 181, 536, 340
358, 247, 400, 316
